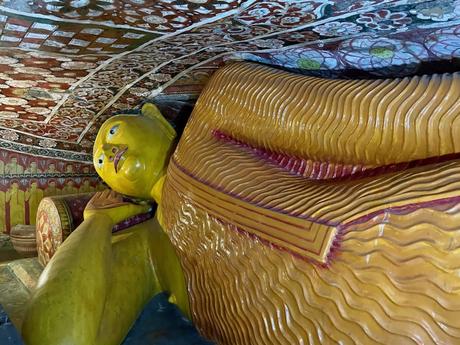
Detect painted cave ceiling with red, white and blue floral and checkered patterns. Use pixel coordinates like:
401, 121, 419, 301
0, 0, 460, 162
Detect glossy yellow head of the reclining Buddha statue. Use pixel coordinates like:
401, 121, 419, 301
93, 104, 176, 202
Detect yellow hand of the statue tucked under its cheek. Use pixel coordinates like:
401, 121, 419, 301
83, 189, 151, 224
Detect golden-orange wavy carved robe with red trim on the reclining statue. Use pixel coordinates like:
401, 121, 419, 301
162, 63, 460, 345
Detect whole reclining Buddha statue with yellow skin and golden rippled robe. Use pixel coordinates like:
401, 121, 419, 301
23, 63, 460, 345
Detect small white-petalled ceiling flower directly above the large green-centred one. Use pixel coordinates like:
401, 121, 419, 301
356, 10, 412, 31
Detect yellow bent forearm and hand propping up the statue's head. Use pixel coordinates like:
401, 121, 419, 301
22, 191, 151, 345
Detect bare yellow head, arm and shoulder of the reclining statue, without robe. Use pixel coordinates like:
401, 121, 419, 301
22, 104, 190, 345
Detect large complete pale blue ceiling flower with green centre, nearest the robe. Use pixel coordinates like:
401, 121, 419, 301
338, 36, 428, 74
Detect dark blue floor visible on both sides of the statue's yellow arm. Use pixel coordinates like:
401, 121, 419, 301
0, 294, 212, 345
